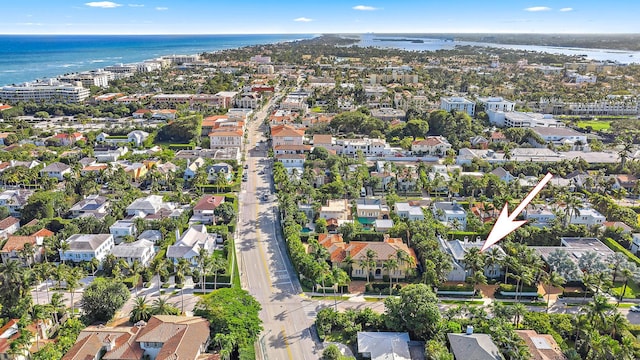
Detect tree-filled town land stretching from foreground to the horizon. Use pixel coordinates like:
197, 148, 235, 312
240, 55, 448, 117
0, 34, 640, 359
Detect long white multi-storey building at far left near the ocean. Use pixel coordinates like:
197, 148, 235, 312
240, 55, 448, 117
0, 83, 91, 103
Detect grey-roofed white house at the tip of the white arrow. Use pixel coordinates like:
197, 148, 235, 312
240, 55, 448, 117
438, 237, 506, 282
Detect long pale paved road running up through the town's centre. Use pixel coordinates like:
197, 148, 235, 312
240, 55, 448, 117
236, 97, 322, 360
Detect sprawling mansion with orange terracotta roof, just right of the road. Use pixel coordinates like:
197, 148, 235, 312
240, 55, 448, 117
318, 234, 418, 279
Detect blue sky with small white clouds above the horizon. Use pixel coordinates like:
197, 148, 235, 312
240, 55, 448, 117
0, 0, 640, 34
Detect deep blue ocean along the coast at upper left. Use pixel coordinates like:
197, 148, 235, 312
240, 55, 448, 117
0, 34, 314, 86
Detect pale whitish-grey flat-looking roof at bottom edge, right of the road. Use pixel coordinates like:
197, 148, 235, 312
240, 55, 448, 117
358, 331, 411, 360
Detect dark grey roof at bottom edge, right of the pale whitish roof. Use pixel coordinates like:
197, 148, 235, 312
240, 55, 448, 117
447, 333, 504, 360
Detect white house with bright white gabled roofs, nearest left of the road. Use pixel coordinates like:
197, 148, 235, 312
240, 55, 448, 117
167, 224, 222, 266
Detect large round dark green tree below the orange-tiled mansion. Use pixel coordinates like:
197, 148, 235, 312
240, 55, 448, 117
384, 284, 441, 340
